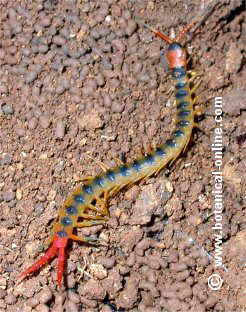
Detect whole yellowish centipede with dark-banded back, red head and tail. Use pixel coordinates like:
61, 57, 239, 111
19, 7, 213, 287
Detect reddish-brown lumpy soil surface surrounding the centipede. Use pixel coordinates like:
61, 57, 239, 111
0, 0, 246, 312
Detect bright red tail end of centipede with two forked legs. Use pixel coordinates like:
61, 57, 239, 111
20, 232, 68, 287
